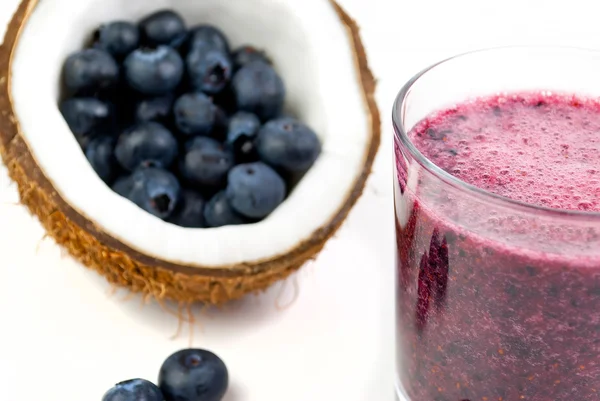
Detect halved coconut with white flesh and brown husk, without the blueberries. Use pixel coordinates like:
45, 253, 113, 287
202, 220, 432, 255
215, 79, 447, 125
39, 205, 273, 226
0, 0, 380, 304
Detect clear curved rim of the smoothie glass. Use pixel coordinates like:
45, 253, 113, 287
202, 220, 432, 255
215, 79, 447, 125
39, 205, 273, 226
392, 45, 600, 221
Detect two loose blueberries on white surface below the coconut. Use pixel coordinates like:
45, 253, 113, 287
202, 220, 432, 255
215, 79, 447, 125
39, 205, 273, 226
102, 349, 229, 401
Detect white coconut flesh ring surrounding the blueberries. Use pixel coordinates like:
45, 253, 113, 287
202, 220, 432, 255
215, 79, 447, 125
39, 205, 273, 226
10, 0, 371, 268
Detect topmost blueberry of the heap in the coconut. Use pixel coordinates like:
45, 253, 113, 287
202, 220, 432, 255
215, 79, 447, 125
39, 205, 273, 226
140, 10, 186, 46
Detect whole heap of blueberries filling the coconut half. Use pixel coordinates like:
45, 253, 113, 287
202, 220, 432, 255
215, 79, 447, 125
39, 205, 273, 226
59, 10, 321, 228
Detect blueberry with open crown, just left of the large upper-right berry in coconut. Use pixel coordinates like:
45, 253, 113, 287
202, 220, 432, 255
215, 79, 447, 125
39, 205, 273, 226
186, 47, 233, 94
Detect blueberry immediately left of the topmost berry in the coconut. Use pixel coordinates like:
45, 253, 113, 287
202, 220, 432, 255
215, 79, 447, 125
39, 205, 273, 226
96, 21, 140, 59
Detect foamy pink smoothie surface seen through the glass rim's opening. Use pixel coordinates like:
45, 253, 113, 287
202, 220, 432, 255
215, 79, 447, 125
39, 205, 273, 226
409, 94, 600, 211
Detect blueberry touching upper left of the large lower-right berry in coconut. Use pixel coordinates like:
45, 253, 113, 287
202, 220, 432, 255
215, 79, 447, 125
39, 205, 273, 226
180, 136, 234, 187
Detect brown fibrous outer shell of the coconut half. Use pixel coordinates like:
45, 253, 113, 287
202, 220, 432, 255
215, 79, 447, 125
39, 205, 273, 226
0, 0, 381, 305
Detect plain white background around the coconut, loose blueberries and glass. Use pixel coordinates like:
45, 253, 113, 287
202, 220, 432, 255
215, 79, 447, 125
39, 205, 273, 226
0, 0, 600, 401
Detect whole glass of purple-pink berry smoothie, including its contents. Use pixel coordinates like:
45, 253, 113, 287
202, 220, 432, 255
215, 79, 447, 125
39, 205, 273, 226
393, 47, 600, 401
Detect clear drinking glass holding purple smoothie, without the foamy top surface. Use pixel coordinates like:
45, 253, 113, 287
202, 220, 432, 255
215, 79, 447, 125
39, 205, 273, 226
393, 47, 600, 401
